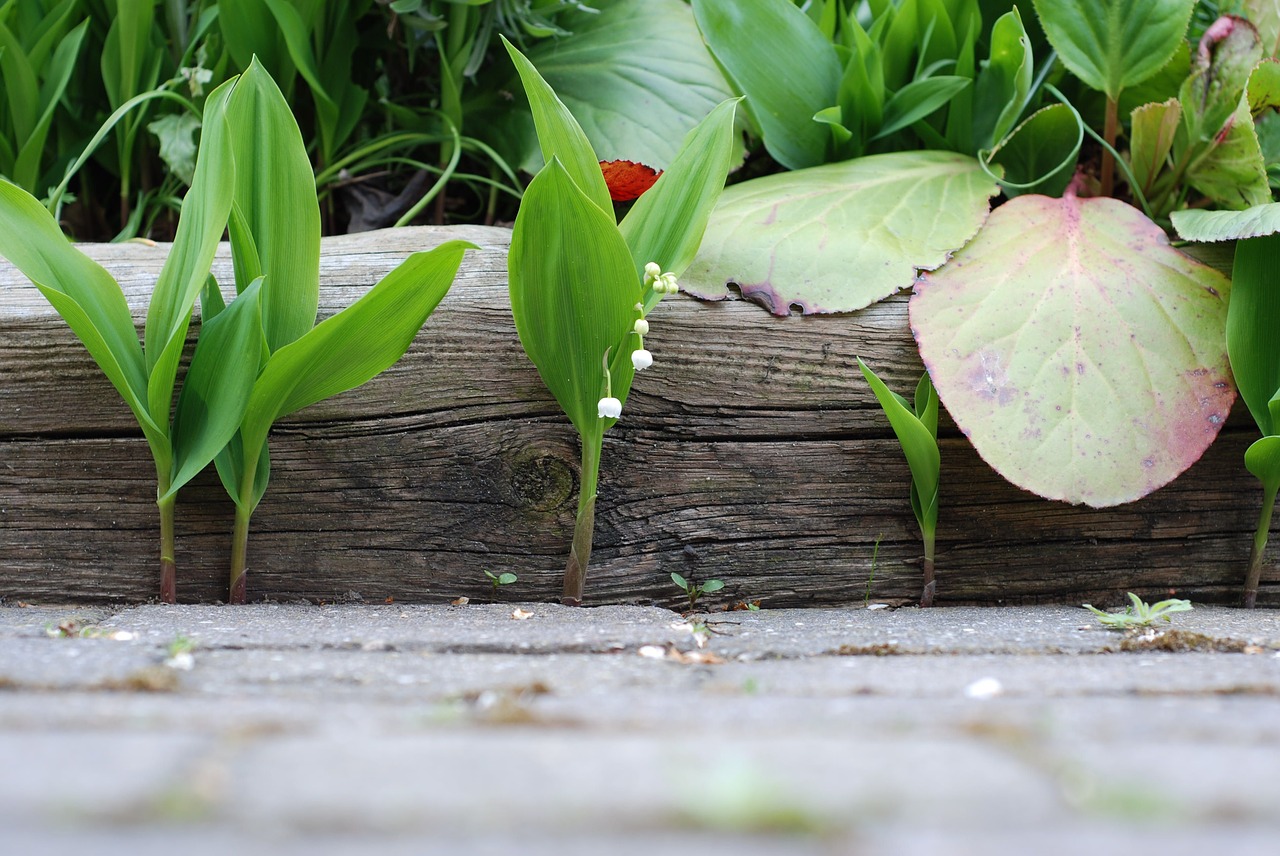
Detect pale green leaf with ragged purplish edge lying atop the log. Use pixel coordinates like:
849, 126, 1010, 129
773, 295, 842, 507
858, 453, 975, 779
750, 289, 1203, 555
681, 151, 1000, 315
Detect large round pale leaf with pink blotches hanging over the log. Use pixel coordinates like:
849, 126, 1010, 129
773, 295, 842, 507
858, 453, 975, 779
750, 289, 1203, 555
910, 192, 1235, 507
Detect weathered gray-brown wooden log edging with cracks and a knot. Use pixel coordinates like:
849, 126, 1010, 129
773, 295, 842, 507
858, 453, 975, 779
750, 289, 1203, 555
0, 226, 1280, 606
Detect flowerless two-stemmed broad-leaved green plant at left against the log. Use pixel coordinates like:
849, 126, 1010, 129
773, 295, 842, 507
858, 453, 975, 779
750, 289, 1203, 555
0, 61, 472, 603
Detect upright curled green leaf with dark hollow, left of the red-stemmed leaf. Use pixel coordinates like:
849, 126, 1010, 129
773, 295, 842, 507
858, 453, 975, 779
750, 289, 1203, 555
973, 6, 1036, 148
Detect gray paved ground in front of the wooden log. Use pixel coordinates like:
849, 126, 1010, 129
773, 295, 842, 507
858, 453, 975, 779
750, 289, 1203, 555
0, 604, 1280, 856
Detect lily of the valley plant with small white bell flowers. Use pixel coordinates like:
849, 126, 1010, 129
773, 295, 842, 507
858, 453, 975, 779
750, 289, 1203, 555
507, 44, 736, 605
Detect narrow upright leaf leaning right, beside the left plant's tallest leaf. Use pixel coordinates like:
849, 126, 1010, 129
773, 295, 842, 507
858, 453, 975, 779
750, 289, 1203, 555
145, 82, 236, 425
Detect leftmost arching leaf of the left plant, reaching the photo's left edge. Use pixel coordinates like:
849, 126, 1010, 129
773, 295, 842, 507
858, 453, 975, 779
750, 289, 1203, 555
0, 180, 151, 431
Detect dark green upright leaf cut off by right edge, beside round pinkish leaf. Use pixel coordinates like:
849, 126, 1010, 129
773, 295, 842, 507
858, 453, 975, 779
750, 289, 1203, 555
1226, 234, 1280, 435
